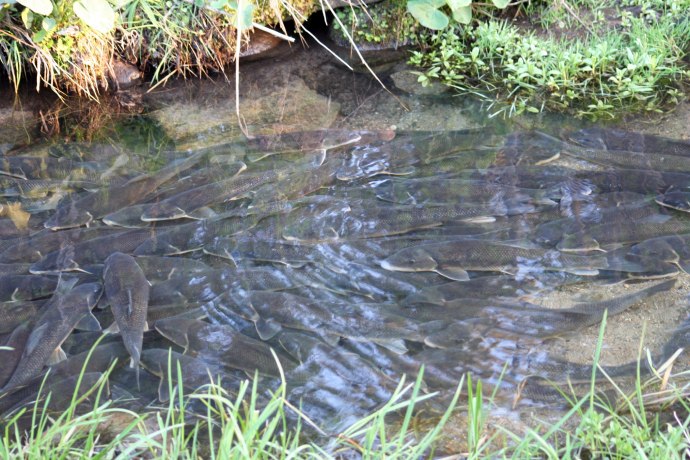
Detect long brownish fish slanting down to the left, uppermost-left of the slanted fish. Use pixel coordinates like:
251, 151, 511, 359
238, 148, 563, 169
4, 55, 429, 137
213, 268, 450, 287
44, 153, 204, 230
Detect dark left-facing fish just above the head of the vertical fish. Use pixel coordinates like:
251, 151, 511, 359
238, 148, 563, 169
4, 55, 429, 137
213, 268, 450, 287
29, 229, 155, 275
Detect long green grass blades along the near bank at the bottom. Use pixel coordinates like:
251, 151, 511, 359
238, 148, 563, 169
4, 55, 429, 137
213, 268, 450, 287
0, 319, 690, 459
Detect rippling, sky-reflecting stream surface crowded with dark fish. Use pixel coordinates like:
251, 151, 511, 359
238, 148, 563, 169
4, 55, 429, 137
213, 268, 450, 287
0, 113, 690, 429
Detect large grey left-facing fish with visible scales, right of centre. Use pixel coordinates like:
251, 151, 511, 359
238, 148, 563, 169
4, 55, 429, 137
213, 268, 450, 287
381, 240, 608, 281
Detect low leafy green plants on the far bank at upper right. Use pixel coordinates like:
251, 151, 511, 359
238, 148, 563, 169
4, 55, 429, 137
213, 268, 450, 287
411, 0, 690, 119
